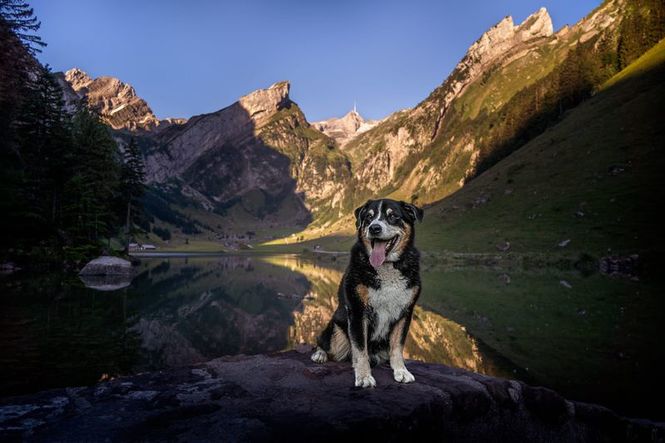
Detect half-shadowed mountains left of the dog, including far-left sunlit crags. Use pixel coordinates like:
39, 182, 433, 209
56, 68, 351, 245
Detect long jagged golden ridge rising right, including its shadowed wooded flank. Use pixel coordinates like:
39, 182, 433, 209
290, 0, 633, 237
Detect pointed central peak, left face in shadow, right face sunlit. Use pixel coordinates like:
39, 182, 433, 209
146, 82, 350, 224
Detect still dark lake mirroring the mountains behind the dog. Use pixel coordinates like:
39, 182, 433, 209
0, 255, 665, 419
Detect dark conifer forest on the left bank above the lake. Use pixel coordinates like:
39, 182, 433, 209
0, 0, 144, 266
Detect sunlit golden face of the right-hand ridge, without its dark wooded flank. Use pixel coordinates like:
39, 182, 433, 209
334, 2, 613, 212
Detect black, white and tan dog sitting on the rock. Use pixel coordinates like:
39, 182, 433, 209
311, 199, 423, 388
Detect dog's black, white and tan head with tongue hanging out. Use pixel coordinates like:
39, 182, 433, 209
355, 199, 423, 268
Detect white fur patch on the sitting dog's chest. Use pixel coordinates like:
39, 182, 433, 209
368, 263, 414, 340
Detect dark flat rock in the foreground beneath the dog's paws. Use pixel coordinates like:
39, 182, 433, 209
0, 351, 665, 441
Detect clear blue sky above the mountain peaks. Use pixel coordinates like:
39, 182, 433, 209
31, 0, 600, 121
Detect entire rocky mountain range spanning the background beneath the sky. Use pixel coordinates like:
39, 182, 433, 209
55, 0, 660, 250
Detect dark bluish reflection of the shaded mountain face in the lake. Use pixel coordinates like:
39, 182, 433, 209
131, 256, 309, 369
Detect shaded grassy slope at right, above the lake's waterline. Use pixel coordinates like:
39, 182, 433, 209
418, 41, 665, 255
